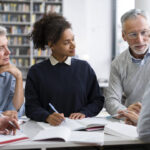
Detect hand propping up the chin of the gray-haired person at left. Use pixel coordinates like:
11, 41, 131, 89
0, 63, 22, 78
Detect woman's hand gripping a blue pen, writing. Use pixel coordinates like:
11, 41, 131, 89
46, 112, 65, 126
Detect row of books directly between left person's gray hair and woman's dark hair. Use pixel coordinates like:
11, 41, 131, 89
5, 25, 30, 34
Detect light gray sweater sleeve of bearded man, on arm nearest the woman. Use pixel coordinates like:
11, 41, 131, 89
105, 63, 126, 115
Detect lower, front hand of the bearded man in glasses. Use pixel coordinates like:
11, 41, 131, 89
118, 110, 139, 126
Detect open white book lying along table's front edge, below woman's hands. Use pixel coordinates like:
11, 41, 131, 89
32, 127, 104, 144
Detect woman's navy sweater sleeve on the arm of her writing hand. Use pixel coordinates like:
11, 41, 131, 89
25, 68, 49, 122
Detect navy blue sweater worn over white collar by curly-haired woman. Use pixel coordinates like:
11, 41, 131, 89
25, 59, 104, 122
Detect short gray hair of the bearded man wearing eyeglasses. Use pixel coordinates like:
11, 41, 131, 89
121, 9, 150, 28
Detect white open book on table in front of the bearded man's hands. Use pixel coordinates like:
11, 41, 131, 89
104, 122, 138, 139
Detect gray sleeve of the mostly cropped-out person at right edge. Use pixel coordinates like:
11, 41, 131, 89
137, 83, 150, 142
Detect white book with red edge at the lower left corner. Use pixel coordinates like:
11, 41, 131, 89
0, 131, 29, 146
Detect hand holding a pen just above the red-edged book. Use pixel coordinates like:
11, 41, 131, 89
0, 116, 20, 135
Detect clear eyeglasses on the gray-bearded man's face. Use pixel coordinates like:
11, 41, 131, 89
127, 30, 150, 40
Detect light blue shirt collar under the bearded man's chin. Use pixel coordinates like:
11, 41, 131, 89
129, 48, 150, 65
